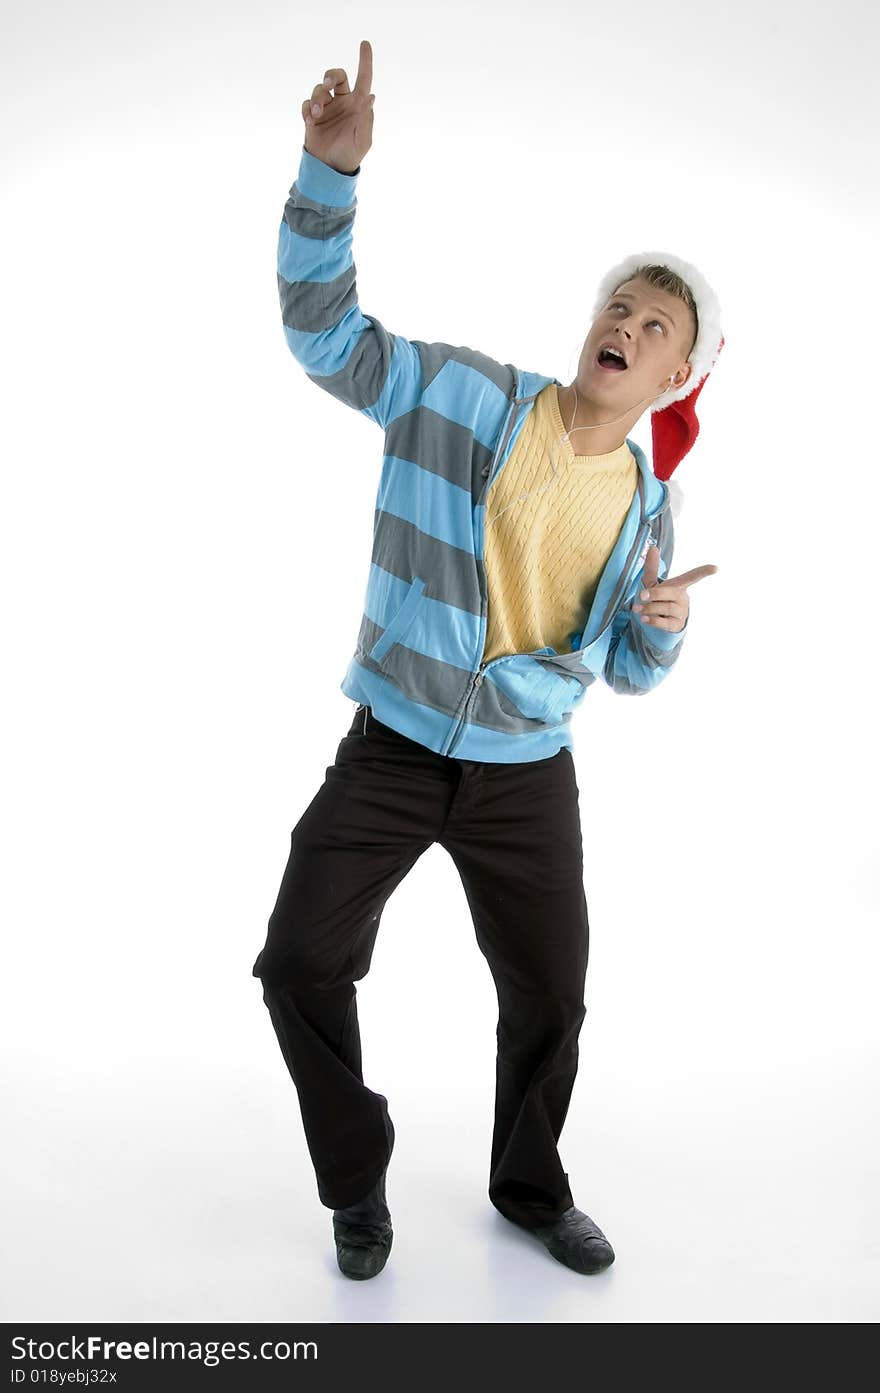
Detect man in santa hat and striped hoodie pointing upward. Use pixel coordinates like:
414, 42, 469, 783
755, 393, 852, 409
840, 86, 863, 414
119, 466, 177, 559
252, 40, 720, 1279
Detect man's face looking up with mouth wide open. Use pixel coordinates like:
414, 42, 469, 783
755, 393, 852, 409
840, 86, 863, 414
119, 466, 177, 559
578, 277, 696, 410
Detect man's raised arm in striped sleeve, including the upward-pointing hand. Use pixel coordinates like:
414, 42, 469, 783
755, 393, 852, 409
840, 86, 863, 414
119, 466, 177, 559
277, 39, 422, 428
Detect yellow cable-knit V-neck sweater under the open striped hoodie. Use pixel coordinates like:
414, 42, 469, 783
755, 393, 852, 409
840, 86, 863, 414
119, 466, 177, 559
483, 382, 639, 662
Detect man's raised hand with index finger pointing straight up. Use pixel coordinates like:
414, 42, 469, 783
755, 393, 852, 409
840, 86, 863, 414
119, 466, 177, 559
302, 39, 375, 174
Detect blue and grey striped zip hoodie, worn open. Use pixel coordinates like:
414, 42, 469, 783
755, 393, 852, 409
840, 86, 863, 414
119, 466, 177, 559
277, 146, 688, 763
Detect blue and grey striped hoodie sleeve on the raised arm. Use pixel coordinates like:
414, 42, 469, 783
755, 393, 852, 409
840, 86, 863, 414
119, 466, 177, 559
277, 146, 422, 428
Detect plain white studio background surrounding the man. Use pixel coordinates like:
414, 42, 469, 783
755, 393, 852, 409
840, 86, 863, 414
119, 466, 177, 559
0, 0, 880, 1322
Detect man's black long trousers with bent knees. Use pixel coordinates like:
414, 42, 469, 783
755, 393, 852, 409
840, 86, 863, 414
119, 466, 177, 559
252, 706, 589, 1227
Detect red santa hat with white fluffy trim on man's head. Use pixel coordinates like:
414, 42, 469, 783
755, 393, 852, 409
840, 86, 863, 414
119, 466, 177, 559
593, 252, 724, 484
